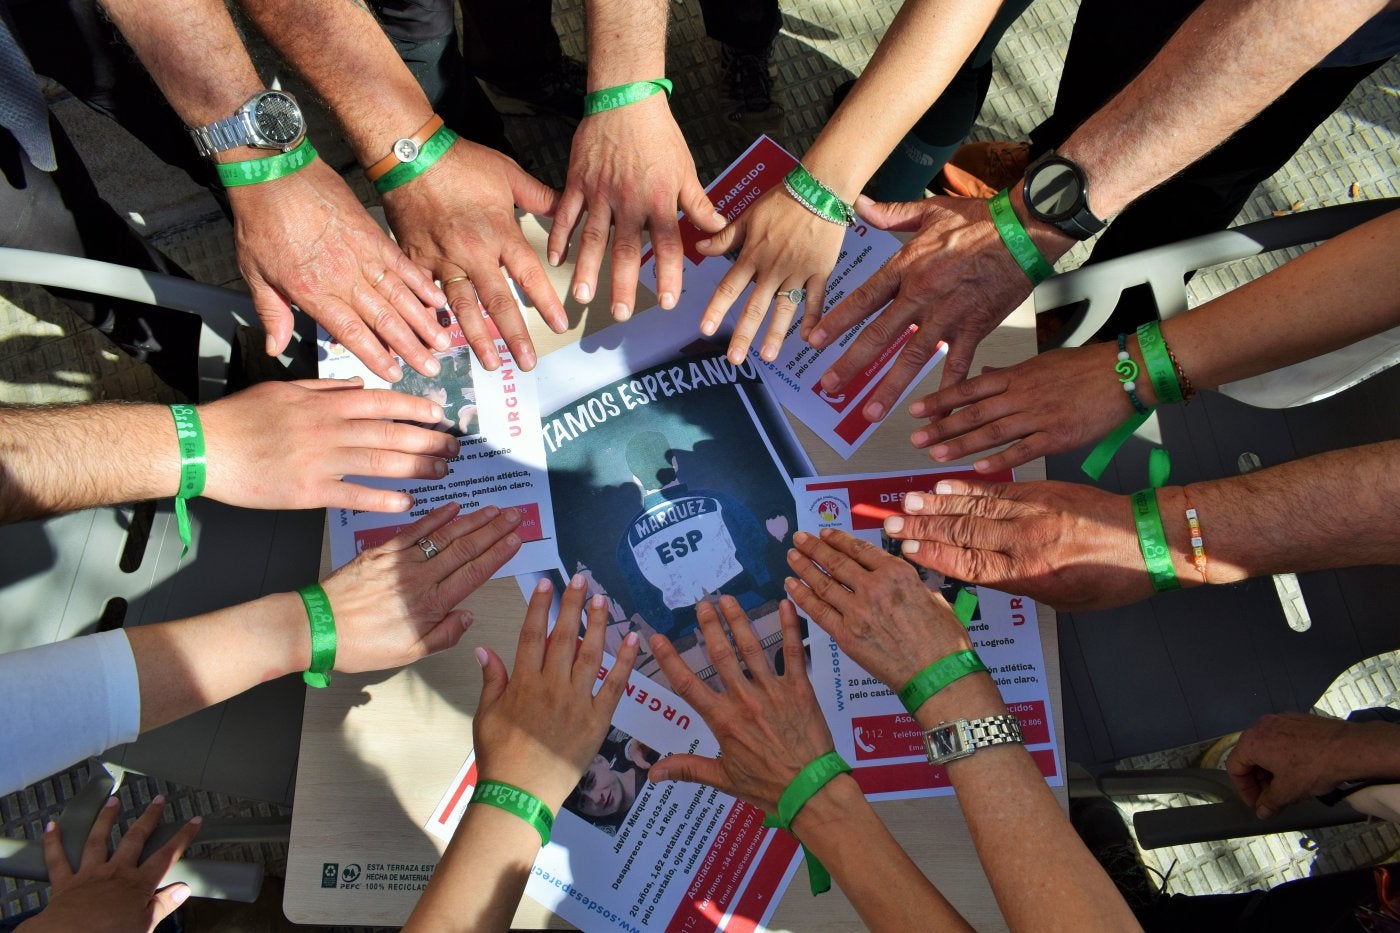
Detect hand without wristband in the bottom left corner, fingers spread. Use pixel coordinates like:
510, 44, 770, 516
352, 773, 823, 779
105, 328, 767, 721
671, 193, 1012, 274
20, 797, 202, 933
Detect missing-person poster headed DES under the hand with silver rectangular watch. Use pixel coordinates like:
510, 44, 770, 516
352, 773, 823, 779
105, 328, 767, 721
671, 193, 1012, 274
795, 467, 1064, 800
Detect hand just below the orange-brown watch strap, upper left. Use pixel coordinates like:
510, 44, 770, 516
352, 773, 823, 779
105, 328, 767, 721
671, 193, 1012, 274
384, 139, 568, 370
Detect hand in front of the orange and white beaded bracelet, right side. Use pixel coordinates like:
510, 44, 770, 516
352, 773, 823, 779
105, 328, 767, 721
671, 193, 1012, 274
885, 479, 1159, 609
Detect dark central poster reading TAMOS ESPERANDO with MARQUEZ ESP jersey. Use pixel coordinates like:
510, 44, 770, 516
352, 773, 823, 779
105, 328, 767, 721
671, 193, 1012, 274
531, 323, 812, 684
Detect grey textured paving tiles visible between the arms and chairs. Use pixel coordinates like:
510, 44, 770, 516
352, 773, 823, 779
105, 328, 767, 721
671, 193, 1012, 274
0, 0, 1400, 916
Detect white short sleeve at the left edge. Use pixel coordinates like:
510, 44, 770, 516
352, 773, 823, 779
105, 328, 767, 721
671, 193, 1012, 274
0, 629, 141, 794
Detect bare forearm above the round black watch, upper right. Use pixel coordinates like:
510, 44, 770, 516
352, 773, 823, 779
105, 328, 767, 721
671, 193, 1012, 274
1060, 0, 1386, 219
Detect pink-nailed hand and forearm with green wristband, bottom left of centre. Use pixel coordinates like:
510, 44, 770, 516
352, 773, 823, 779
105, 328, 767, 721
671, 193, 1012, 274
403, 576, 638, 932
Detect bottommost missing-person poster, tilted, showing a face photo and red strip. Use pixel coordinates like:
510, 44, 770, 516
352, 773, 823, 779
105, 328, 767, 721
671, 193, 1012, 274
427, 656, 801, 933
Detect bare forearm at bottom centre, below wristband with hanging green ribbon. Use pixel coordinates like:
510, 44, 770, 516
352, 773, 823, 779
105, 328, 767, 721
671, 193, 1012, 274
792, 775, 970, 930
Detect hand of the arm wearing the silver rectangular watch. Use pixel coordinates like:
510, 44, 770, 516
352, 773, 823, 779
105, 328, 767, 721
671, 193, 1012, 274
787, 531, 972, 693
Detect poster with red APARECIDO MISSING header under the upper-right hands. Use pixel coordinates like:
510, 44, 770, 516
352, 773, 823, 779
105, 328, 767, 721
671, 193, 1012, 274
643, 136, 945, 457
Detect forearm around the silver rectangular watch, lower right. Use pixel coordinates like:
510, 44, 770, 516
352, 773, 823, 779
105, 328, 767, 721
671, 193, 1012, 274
917, 674, 1137, 930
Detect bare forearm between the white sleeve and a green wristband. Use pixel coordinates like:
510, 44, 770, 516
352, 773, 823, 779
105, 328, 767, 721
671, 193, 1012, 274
126, 593, 311, 733
